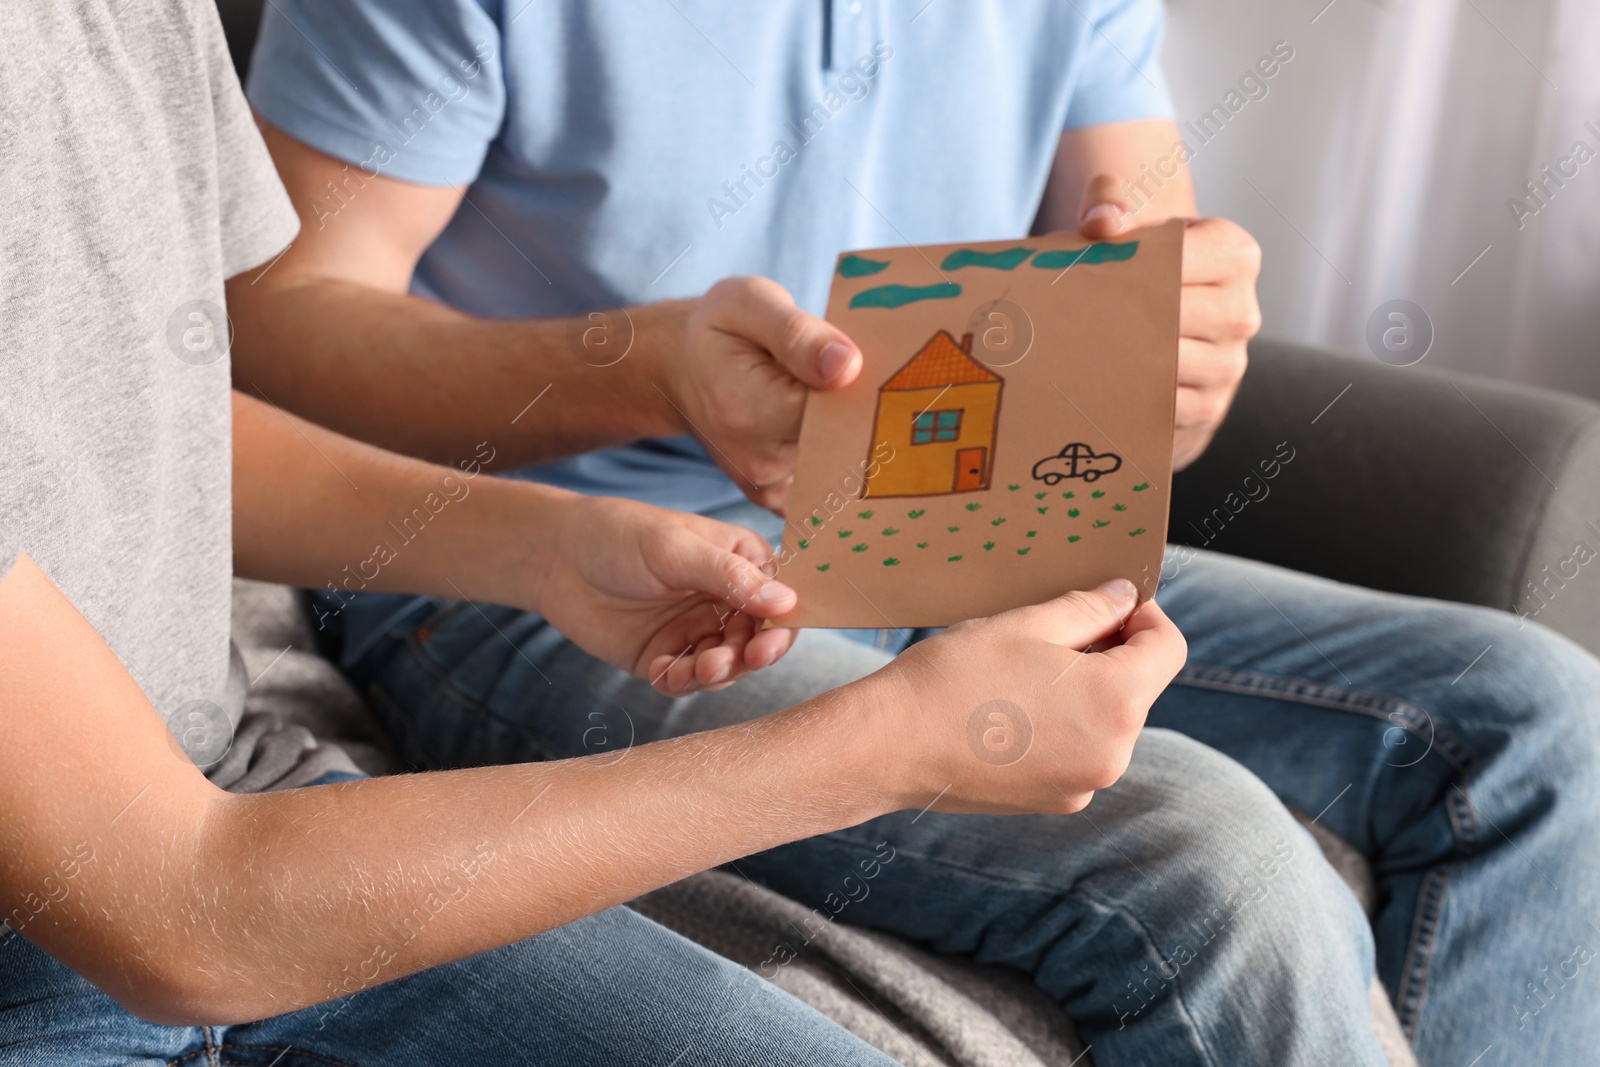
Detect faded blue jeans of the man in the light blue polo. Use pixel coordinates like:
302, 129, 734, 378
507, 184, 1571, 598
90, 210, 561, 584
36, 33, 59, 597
340, 509, 1600, 1067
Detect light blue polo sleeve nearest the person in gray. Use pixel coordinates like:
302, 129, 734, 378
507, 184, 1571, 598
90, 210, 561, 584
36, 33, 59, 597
248, 0, 506, 186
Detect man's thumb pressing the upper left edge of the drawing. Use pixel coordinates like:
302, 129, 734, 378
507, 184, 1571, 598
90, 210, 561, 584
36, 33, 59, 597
715, 278, 862, 389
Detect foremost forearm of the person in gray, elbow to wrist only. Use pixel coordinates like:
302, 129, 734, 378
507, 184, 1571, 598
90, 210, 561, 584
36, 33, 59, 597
187, 694, 891, 1022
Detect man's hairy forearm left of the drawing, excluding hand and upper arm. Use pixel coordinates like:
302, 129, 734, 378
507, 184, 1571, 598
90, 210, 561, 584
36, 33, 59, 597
229, 272, 683, 467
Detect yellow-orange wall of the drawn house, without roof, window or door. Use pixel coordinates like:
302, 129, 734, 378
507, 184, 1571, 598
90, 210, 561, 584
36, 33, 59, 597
864, 382, 1000, 496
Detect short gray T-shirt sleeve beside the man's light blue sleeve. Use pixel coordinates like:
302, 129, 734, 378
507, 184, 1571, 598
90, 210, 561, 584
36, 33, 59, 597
202, 3, 299, 278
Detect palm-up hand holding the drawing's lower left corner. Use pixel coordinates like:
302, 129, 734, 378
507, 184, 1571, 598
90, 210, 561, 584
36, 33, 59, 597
536, 498, 795, 696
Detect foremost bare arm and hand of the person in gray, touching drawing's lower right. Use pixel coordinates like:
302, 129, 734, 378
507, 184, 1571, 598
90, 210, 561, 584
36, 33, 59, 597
0, 543, 1182, 1025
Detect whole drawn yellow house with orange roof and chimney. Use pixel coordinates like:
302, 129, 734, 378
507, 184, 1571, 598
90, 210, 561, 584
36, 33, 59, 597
862, 330, 1005, 496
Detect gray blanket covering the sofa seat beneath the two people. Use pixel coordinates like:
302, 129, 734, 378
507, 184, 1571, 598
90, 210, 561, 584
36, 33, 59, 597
233, 581, 1416, 1067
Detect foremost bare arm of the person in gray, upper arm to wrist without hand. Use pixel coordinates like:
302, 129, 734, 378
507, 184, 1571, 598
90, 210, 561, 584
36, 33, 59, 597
0, 558, 907, 1025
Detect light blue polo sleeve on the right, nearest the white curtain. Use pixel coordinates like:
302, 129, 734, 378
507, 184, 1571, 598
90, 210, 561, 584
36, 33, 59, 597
1064, 0, 1173, 130
